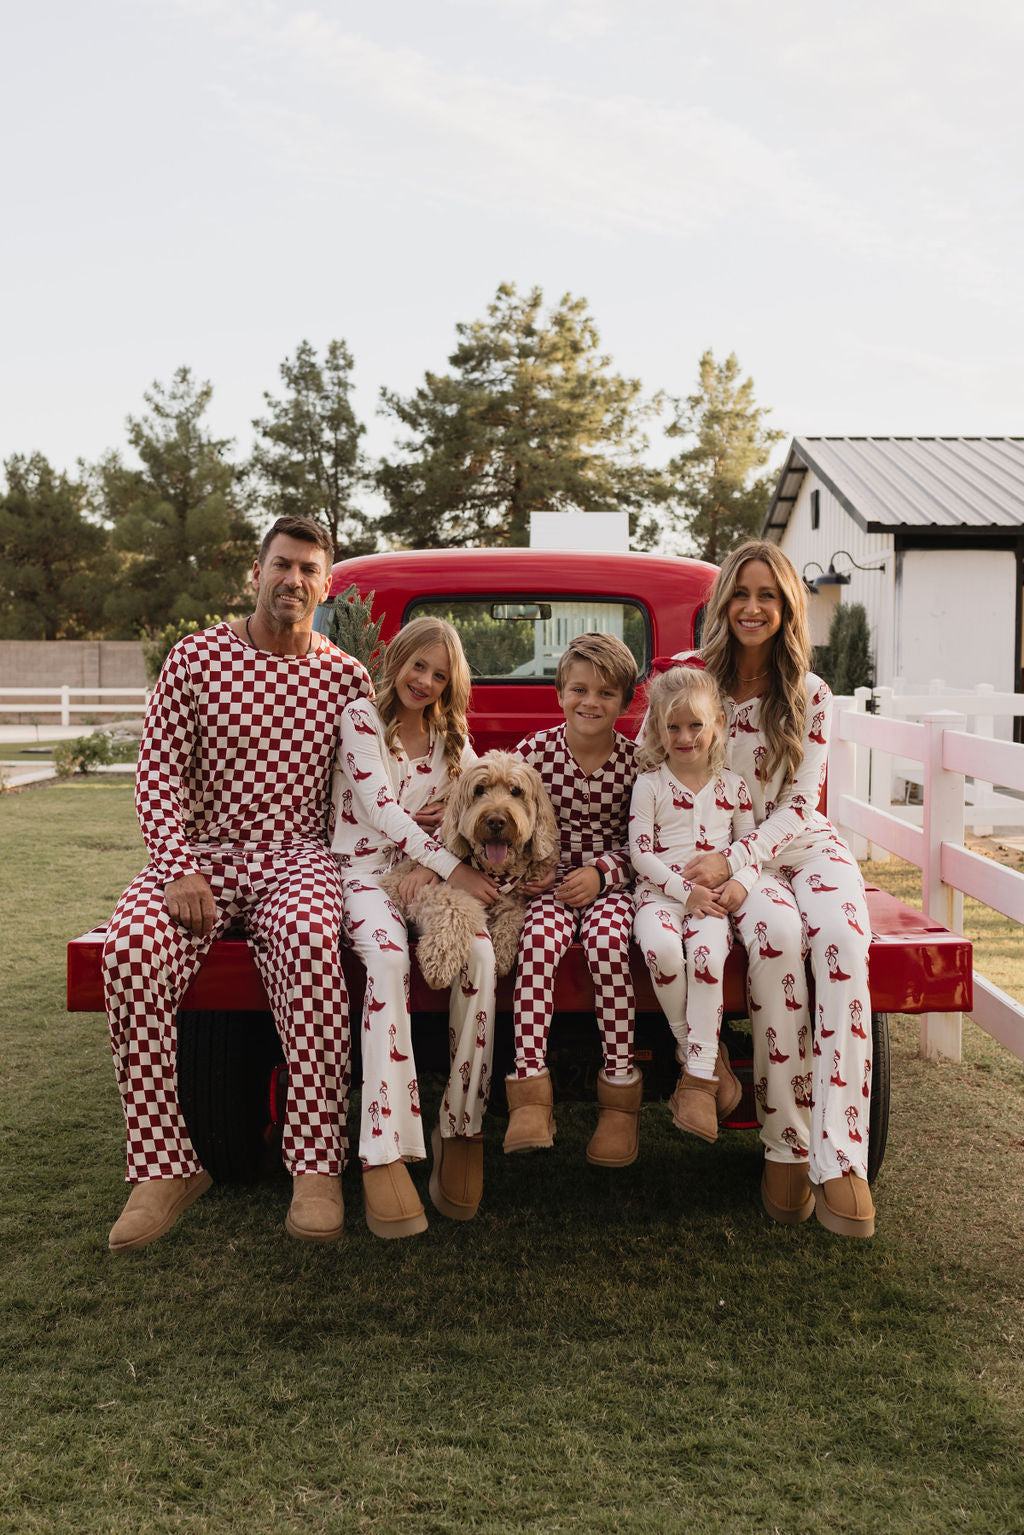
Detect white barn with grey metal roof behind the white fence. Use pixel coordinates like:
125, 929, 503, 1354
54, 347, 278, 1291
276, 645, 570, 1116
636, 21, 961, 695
761, 437, 1024, 692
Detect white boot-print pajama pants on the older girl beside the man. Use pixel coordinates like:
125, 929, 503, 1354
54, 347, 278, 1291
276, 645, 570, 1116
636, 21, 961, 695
342, 875, 496, 1167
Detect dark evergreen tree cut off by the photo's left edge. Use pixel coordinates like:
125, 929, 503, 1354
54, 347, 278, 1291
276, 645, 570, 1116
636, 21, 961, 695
0, 453, 115, 640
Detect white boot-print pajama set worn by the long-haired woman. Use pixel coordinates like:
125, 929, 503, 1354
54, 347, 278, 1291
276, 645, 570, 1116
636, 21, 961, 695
725, 672, 870, 1183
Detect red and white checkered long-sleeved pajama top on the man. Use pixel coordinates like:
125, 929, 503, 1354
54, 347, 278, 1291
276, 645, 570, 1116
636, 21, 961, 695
135, 623, 373, 881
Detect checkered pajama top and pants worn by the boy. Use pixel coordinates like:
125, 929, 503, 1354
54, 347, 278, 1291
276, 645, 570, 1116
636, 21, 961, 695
514, 725, 637, 1079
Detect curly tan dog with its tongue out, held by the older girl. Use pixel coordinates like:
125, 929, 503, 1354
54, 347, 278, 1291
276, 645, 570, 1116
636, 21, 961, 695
381, 752, 559, 990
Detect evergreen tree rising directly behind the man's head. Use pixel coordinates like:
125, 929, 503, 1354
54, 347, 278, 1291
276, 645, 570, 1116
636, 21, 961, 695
252, 341, 376, 560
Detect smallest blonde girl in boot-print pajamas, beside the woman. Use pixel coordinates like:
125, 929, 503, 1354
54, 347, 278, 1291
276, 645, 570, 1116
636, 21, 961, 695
629, 660, 757, 1141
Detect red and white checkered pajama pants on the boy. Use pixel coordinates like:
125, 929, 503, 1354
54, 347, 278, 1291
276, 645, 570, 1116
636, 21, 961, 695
513, 890, 634, 1078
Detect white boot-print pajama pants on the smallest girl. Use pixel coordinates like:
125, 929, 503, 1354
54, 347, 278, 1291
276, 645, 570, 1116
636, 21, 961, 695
633, 893, 732, 1076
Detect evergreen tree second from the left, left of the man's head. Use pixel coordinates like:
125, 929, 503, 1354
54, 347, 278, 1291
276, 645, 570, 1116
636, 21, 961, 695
97, 367, 256, 634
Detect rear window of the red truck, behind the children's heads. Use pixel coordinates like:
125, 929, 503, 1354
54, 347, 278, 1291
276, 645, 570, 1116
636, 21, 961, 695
405, 596, 651, 682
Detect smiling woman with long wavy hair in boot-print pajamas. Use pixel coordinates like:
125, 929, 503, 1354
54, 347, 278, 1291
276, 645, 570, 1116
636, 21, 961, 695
683, 540, 875, 1237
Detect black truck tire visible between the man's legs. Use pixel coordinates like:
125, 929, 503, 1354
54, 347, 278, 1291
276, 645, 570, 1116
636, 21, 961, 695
178, 1010, 282, 1183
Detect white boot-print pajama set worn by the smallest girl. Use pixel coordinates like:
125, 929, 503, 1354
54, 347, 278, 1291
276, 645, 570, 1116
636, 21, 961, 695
629, 763, 757, 1076
